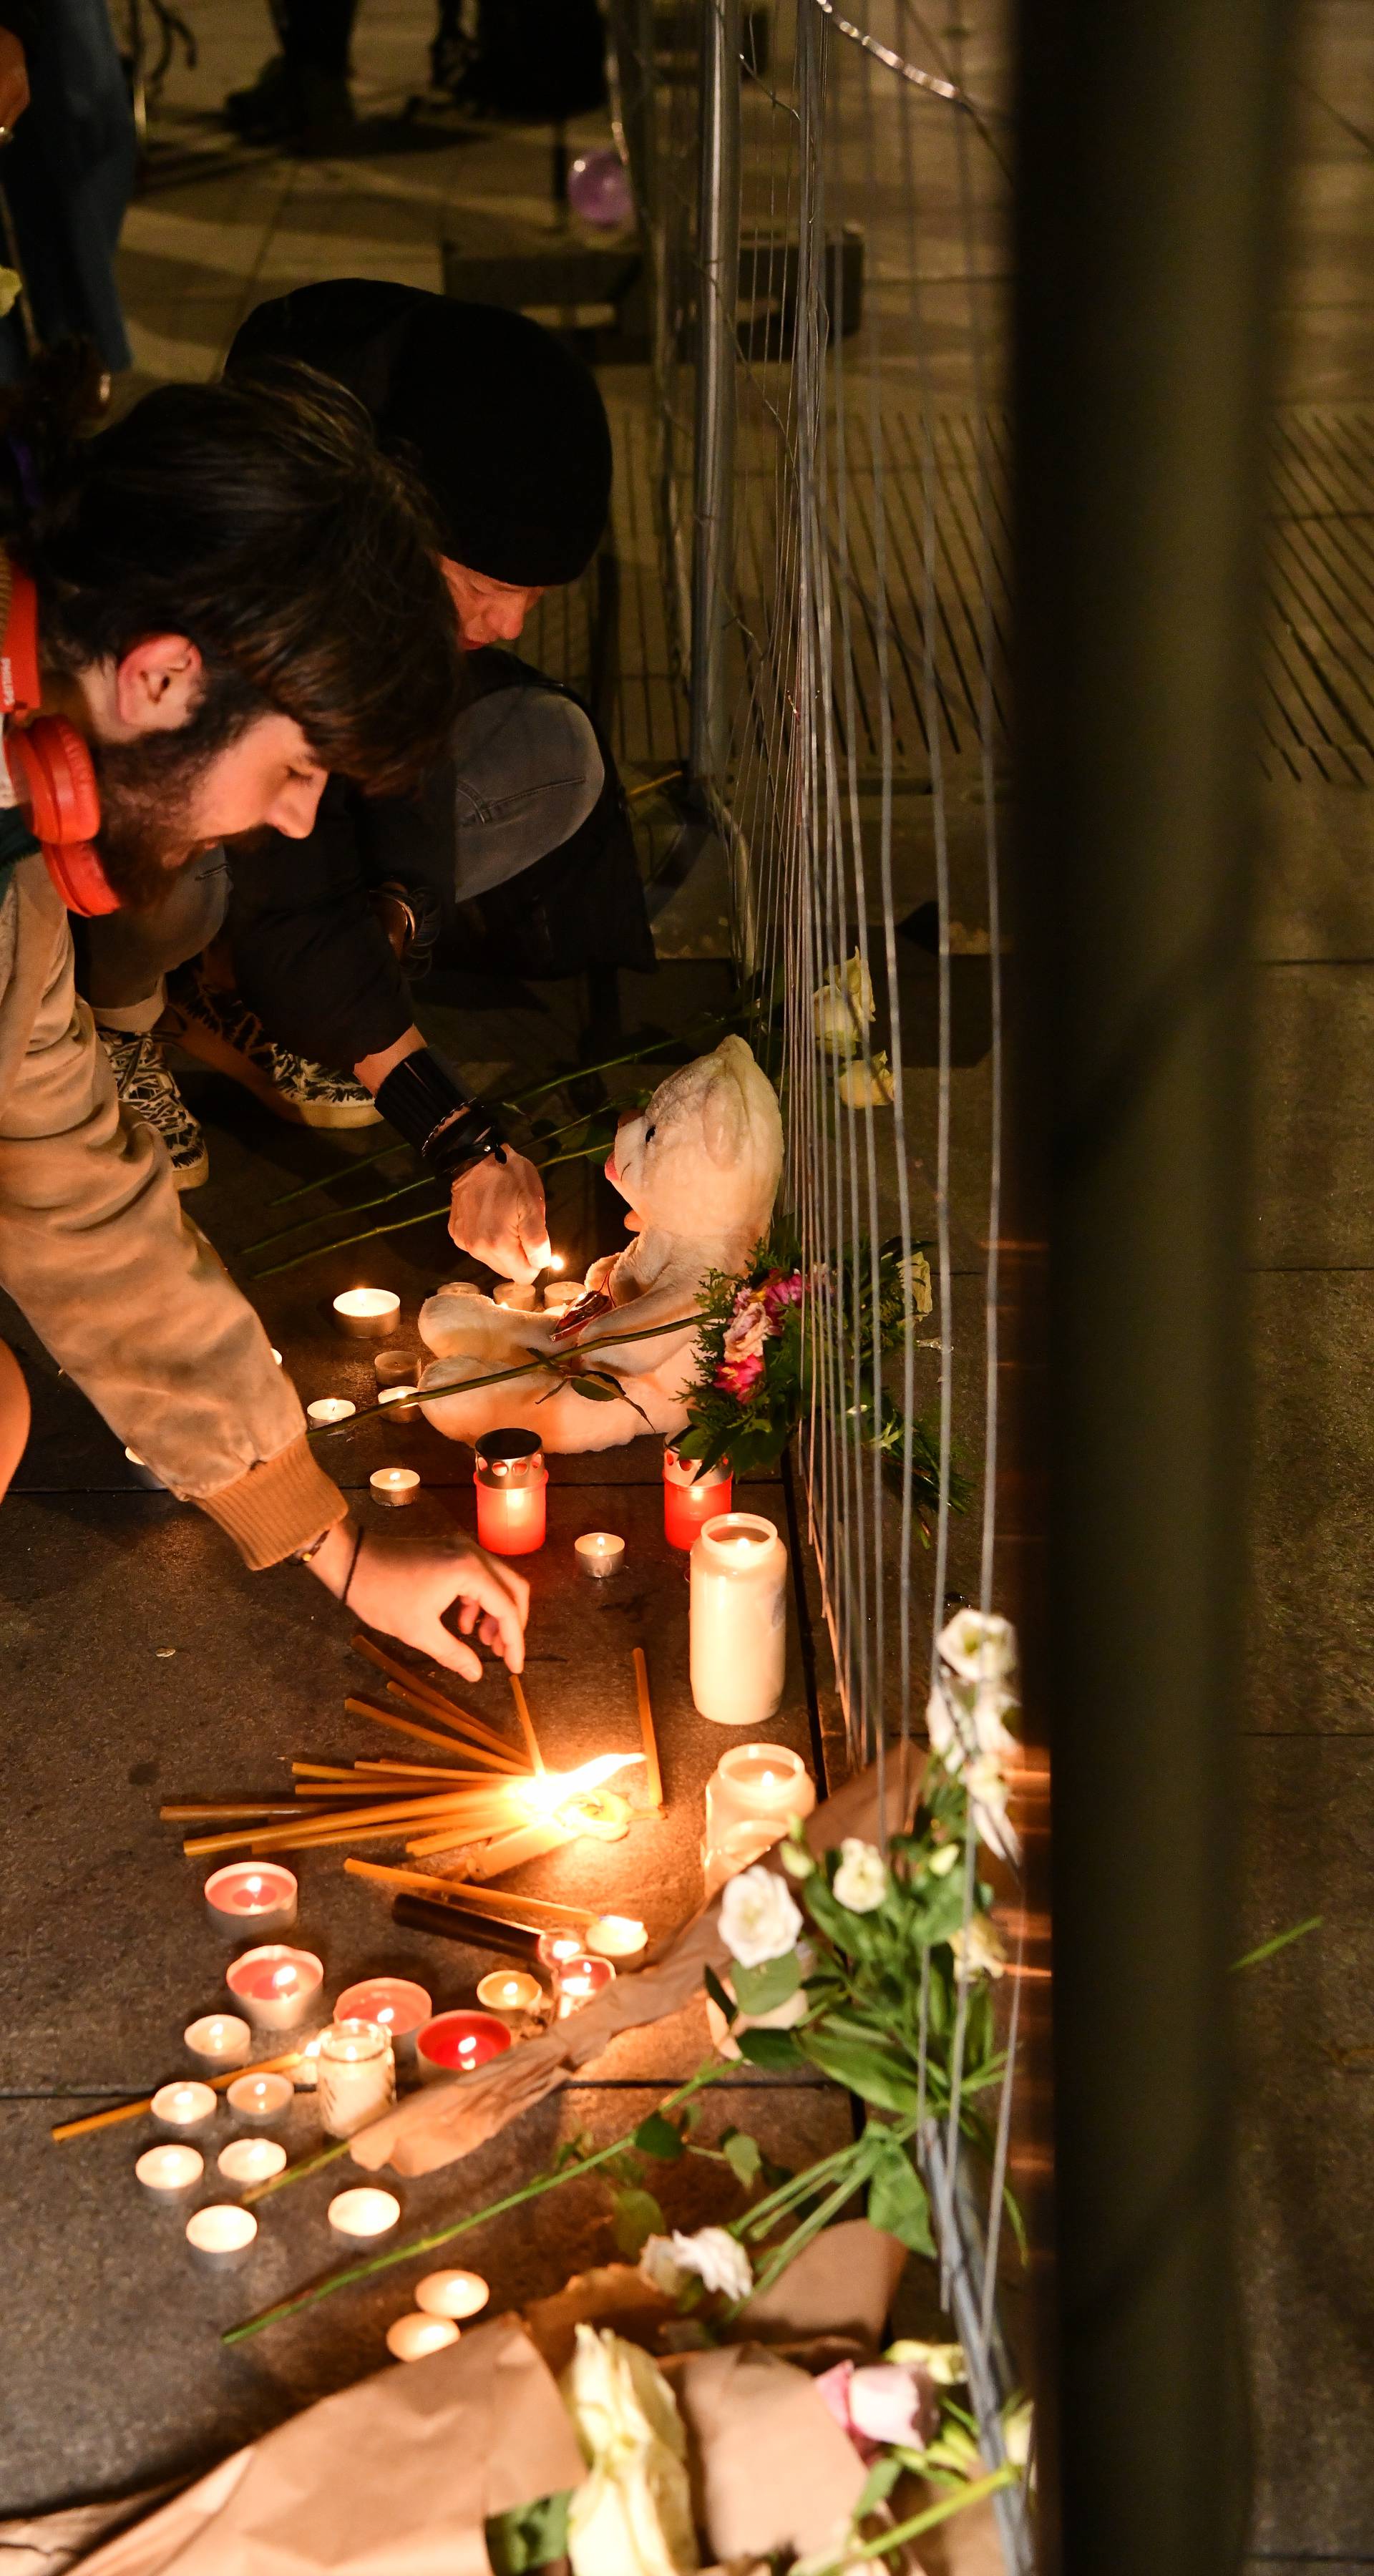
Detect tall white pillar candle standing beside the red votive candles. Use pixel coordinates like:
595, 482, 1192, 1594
691, 1512, 786, 1726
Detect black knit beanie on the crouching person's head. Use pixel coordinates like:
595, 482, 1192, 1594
227, 278, 611, 590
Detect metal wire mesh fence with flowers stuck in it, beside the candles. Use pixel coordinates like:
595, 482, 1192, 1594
611, 0, 1031, 2568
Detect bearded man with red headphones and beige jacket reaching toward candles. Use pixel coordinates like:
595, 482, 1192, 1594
0, 361, 528, 1679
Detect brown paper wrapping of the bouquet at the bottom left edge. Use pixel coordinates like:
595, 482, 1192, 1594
71, 2318, 585, 2576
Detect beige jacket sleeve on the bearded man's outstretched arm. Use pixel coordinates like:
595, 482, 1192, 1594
0, 858, 346, 1566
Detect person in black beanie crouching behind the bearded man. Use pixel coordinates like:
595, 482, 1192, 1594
82, 278, 655, 1278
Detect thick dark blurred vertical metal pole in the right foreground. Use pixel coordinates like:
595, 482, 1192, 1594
1008, 0, 1287, 2576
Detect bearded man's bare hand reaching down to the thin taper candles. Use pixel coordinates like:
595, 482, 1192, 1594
309, 1520, 528, 1682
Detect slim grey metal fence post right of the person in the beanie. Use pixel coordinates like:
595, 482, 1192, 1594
688, 0, 740, 806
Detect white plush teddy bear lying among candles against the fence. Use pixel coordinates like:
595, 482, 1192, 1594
420, 1038, 784, 1450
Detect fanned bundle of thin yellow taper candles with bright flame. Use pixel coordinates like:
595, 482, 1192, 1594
160, 1636, 663, 1896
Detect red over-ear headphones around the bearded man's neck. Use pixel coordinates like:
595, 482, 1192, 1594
0, 564, 119, 914
